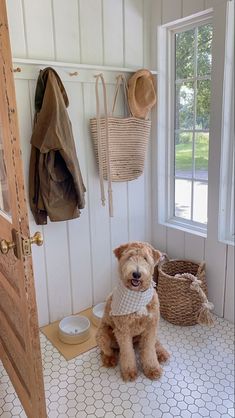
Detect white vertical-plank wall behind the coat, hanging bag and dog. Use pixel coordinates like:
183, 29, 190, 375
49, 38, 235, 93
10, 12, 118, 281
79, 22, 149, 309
7, 0, 234, 325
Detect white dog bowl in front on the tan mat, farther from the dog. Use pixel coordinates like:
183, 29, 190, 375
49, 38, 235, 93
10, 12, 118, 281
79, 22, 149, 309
59, 315, 91, 344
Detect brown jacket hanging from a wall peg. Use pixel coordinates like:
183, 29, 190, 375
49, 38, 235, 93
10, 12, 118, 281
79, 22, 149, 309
29, 68, 86, 225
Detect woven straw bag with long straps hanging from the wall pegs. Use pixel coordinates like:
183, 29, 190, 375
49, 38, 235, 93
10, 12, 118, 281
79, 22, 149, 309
90, 74, 151, 216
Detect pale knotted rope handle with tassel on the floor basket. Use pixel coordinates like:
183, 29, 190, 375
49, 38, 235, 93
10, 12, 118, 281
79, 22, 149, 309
175, 272, 214, 325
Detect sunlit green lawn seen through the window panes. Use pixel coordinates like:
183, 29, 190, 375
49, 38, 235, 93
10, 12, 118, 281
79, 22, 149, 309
175, 134, 209, 171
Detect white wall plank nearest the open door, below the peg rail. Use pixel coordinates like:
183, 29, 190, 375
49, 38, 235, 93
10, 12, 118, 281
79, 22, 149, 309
15, 80, 49, 325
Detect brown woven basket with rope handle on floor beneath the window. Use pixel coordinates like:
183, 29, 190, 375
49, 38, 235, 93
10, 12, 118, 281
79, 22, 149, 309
157, 257, 214, 325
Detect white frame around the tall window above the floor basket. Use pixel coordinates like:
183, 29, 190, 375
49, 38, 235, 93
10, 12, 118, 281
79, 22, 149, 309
157, 9, 213, 237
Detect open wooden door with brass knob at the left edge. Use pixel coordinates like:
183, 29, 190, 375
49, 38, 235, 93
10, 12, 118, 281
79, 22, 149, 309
0, 0, 47, 418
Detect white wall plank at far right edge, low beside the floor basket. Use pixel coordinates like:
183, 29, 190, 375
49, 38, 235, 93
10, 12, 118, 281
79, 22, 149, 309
224, 245, 235, 322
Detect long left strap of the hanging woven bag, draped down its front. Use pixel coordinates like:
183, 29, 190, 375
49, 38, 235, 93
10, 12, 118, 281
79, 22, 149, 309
95, 73, 113, 217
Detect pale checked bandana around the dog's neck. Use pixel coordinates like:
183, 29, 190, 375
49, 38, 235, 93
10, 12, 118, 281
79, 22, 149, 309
111, 280, 155, 316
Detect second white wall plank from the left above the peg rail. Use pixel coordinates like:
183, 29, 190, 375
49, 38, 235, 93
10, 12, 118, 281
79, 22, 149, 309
23, 0, 54, 60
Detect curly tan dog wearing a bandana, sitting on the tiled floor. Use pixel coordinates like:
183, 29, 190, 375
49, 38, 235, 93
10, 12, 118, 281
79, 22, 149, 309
96, 242, 169, 381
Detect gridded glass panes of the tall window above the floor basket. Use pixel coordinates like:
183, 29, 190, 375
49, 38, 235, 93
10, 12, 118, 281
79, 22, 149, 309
174, 24, 212, 224
